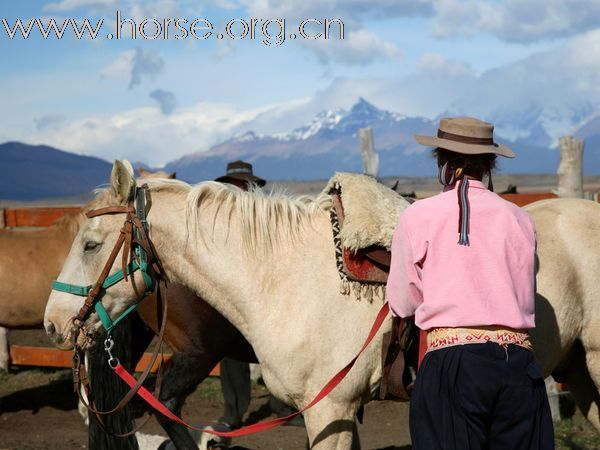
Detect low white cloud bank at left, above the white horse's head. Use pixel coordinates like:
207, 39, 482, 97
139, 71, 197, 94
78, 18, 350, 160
19, 102, 298, 165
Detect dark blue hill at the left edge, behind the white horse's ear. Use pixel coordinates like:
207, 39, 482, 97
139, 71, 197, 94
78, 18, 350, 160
0, 142, 112, 200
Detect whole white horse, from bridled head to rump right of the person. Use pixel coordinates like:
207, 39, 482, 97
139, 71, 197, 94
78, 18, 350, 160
45, 162, 600, 449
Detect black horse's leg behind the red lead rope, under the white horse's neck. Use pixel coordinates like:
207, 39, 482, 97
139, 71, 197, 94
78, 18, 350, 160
156, 353, 216, 450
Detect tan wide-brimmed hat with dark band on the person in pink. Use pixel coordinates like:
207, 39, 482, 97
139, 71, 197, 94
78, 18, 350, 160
414, 117, 516, 158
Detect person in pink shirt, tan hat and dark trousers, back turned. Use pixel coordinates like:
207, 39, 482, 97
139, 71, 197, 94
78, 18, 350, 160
387, 117, 554, 450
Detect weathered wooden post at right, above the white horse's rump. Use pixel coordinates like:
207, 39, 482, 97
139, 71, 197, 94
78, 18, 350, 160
554, 136, 585, 198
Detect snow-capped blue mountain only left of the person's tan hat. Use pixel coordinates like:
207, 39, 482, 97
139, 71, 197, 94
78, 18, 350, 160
166, 98, 436, 181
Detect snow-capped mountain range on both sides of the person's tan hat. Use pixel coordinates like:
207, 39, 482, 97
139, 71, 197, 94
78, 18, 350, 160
165, 98, 600, 182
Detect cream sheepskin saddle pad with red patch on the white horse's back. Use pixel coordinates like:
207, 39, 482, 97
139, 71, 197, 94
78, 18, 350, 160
324, 172, 410, 283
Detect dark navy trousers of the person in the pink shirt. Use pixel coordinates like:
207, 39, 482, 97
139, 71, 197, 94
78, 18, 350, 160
410, 342, 554, 450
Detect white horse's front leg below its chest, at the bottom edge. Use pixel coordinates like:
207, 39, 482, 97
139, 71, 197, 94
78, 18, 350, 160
303, 398, 360, 450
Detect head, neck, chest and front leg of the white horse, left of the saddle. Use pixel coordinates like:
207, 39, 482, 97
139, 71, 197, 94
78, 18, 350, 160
45, 162, 389, 449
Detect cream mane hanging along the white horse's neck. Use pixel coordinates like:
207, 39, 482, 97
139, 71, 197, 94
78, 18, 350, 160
186, 181, 332, 255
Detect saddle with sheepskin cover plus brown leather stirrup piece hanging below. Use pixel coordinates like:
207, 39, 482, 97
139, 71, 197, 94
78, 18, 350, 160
325, 173, 418, 401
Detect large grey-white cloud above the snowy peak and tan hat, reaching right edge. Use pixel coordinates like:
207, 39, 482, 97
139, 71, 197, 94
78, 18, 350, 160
284, 30, 600, 145
